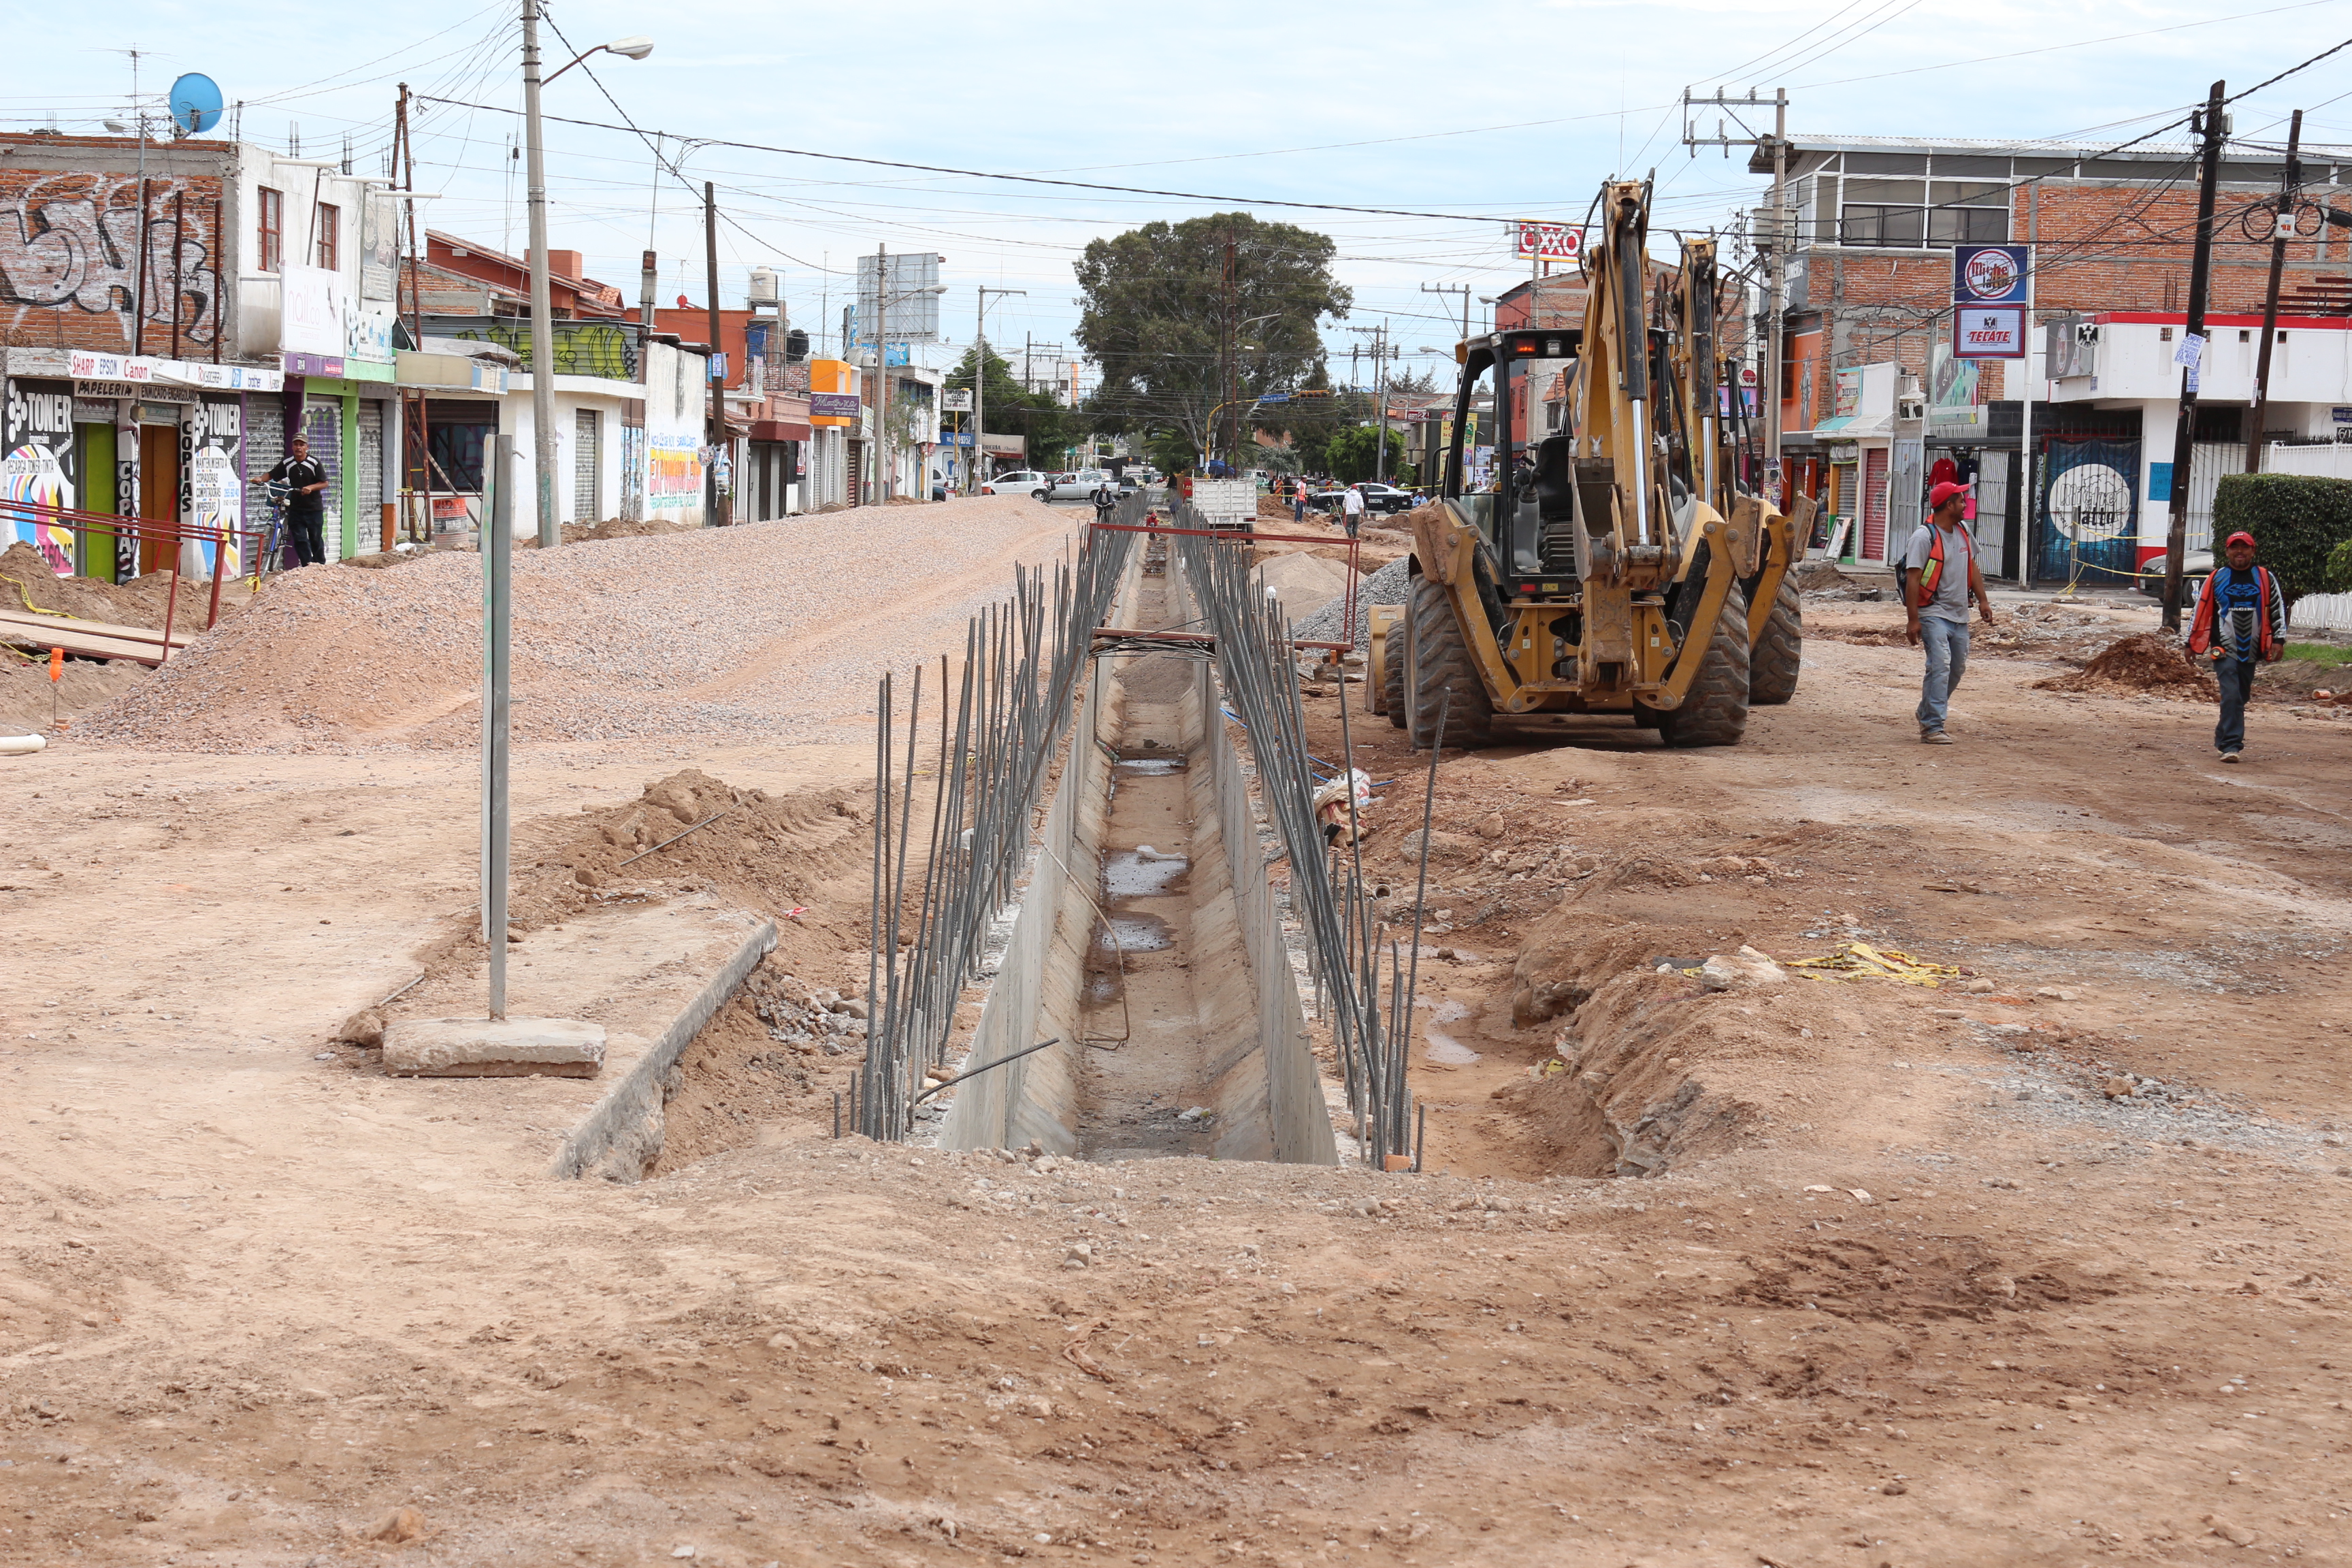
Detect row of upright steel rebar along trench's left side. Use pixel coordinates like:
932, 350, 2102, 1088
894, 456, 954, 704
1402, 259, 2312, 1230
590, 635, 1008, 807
851, 493, 1143, 1143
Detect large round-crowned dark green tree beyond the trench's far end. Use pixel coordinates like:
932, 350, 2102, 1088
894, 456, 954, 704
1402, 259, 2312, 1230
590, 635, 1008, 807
1077, 212, 1355, 466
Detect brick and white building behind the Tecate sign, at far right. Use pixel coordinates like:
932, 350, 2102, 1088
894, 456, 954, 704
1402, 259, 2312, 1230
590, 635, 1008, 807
1750, 136, 2352, 578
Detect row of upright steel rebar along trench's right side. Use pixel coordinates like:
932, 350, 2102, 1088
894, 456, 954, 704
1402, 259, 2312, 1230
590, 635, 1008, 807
1169, 501, 1418, 1171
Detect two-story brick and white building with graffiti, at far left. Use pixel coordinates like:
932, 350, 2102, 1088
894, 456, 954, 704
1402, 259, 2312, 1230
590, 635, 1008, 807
0, 131, 402, 581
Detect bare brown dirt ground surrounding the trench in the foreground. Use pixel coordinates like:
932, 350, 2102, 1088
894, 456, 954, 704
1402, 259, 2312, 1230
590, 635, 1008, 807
0, 557, 2352, 1568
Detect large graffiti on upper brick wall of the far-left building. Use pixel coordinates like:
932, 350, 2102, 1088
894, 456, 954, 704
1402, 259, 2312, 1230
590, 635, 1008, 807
0, 169, 221, 353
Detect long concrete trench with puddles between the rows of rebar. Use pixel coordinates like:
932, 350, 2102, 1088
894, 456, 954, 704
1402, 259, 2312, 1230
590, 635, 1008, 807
938, 550, 1338, 1164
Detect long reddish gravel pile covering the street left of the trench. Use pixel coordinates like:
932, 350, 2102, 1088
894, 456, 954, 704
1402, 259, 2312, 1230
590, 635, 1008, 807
76, 496, 1070, 752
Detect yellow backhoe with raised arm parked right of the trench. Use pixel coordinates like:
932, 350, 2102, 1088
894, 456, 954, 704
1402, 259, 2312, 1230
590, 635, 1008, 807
1373, 181, 1792, 745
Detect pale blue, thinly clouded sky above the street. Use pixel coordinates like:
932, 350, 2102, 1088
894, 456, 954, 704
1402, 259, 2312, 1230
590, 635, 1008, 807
18, 0, 2352, 392
